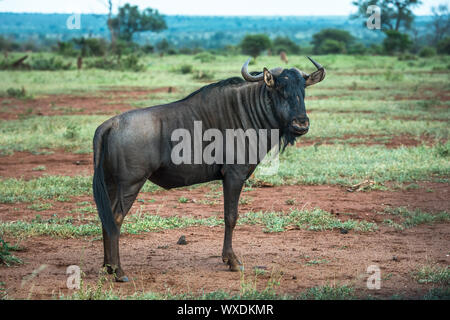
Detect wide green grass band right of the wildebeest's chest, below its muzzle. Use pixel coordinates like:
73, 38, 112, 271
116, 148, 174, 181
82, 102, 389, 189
256, 142, 450, 185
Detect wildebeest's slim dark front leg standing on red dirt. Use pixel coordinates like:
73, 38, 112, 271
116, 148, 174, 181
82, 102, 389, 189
222, 169, 245, 271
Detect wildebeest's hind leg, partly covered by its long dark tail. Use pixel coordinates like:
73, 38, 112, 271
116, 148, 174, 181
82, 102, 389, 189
103, 172, 147, 282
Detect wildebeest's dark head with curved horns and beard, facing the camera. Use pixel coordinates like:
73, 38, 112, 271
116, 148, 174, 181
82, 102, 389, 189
242, 57, 326, 146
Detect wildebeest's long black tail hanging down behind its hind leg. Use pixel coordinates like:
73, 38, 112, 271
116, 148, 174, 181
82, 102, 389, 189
92, 122, 119, 236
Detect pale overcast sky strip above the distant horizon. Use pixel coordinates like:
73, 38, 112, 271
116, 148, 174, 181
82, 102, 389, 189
0, 0, 444, 16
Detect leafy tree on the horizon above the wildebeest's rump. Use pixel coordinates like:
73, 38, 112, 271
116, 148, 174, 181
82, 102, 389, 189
110, 3, 167, 42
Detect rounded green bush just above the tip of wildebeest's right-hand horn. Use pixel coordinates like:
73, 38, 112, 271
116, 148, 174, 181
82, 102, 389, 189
312, 29, 355, 54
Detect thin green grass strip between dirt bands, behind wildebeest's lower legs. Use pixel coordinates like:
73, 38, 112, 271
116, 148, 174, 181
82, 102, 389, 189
0, 207, 377, 238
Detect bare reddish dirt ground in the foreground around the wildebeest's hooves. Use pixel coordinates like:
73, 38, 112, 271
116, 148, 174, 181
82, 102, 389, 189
0, 152, 450, 299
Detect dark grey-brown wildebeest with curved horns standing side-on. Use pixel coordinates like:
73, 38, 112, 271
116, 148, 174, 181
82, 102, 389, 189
93, 58, 326, 282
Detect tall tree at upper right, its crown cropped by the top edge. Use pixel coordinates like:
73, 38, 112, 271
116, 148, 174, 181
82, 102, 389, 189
351, 0, 422, 31
